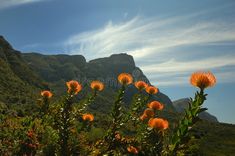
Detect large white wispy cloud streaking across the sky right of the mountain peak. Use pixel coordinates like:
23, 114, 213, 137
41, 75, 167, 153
65, 9, 235, 86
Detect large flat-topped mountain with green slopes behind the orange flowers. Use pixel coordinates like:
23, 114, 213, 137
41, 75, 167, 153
0, 36, 174, 113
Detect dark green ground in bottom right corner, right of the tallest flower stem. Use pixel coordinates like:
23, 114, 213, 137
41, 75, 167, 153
185, 120, 235, 156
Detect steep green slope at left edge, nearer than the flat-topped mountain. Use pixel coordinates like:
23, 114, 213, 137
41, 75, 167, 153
0, 36, 41, 107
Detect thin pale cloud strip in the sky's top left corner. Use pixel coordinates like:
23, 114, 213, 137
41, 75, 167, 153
0, 0, 45, 9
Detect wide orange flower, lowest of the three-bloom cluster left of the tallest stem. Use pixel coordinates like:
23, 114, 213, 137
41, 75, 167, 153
148, 118, 169, 130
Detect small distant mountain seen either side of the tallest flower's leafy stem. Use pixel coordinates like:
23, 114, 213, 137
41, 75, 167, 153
173, 98, 218, 122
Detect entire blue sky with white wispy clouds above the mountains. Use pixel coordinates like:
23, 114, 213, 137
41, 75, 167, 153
0, 0, 235, 123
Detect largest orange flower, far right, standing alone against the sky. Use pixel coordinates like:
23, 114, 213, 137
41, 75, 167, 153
190, 72, 216, 89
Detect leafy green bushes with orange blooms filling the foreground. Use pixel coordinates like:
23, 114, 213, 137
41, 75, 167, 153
0, 72, 216, 156
